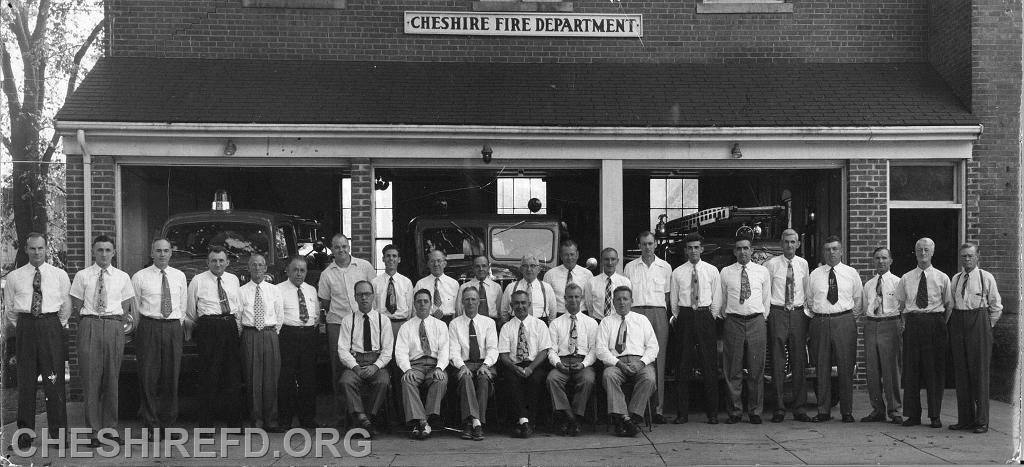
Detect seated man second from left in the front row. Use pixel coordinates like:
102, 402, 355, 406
394, 289, 449, 439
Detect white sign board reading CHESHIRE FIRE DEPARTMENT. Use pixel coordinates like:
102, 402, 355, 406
406, 11, 643, 38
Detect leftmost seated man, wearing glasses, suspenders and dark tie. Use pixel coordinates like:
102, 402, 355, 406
338, 281, 394, 437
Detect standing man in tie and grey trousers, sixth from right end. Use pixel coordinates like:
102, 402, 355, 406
717, 236, 771, 425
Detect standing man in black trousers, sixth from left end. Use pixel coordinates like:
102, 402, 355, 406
278, 256, 319, 429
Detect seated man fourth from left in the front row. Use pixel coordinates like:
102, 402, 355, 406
498, 286, 551, 438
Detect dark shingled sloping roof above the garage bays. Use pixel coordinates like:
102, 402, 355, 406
57, 57, 978, 127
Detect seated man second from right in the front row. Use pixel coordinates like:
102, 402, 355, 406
548, 283, 598, 436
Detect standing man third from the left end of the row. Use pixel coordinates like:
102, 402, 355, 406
131, 239, 188, 439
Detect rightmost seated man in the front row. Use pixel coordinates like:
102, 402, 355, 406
597, 286, 658, 436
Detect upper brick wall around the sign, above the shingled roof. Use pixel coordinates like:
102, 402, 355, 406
105, 0, 928, 62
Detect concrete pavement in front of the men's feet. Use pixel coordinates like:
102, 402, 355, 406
3, 389, 1014, 466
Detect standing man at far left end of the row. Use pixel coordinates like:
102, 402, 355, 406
3, 232, 71, 451
